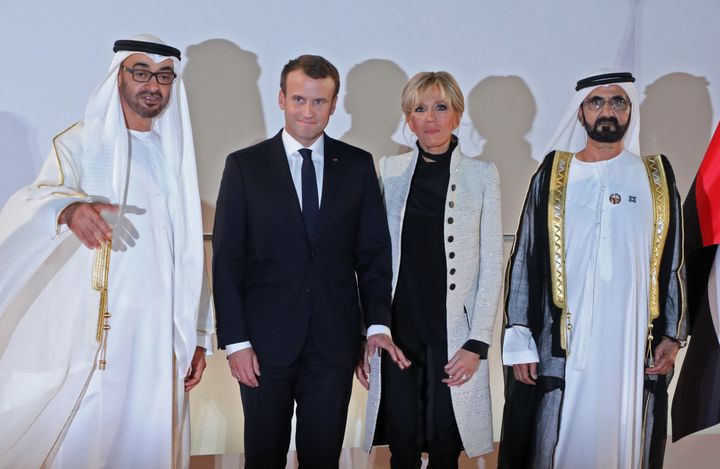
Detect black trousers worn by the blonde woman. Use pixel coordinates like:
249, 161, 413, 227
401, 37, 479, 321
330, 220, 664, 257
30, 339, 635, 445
382, 343, 462, 469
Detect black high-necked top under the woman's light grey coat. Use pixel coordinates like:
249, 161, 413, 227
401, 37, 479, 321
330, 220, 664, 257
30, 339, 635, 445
393, 138, 487, 354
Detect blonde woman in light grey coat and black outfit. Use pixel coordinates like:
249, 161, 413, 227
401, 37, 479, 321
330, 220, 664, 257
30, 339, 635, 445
357, 72, 502, 468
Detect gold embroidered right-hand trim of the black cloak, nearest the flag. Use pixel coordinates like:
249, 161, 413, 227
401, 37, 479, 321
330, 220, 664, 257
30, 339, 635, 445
643, 155, 670, 358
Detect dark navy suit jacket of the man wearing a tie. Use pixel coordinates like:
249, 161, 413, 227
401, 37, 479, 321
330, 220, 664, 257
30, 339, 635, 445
213, 133, 392, 367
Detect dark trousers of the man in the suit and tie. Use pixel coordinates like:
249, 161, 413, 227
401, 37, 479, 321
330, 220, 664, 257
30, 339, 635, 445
240, 332, 353, 469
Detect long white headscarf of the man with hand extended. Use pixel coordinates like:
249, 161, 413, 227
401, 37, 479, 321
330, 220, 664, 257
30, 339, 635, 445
82, 34, 204, 374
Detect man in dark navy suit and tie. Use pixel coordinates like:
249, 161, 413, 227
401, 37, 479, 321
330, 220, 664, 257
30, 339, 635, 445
213, 55, 410, 468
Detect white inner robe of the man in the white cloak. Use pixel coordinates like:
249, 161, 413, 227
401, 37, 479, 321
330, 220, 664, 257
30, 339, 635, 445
53, 131, 189, 469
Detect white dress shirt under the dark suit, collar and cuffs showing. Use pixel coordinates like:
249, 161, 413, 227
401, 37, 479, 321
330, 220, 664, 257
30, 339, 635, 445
225, 129, 391, 356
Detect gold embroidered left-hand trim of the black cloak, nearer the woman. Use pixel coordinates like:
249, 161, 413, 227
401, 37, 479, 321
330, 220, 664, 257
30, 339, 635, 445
548, 151, 572, 355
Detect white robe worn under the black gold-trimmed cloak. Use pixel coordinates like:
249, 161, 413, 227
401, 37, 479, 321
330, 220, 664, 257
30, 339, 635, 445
555, 151, 653, 469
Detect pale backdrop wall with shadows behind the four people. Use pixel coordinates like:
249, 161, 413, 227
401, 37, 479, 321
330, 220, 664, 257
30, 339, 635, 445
0, 0, 720, 453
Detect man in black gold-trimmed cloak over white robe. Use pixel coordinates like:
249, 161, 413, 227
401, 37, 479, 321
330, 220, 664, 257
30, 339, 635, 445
499, 73, 686, 469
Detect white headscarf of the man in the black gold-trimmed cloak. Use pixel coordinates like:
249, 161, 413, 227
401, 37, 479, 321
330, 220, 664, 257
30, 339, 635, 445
538, 69, 640, 160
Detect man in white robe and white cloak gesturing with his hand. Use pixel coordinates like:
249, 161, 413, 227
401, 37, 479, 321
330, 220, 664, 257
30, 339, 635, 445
0, 35, 212, 469
